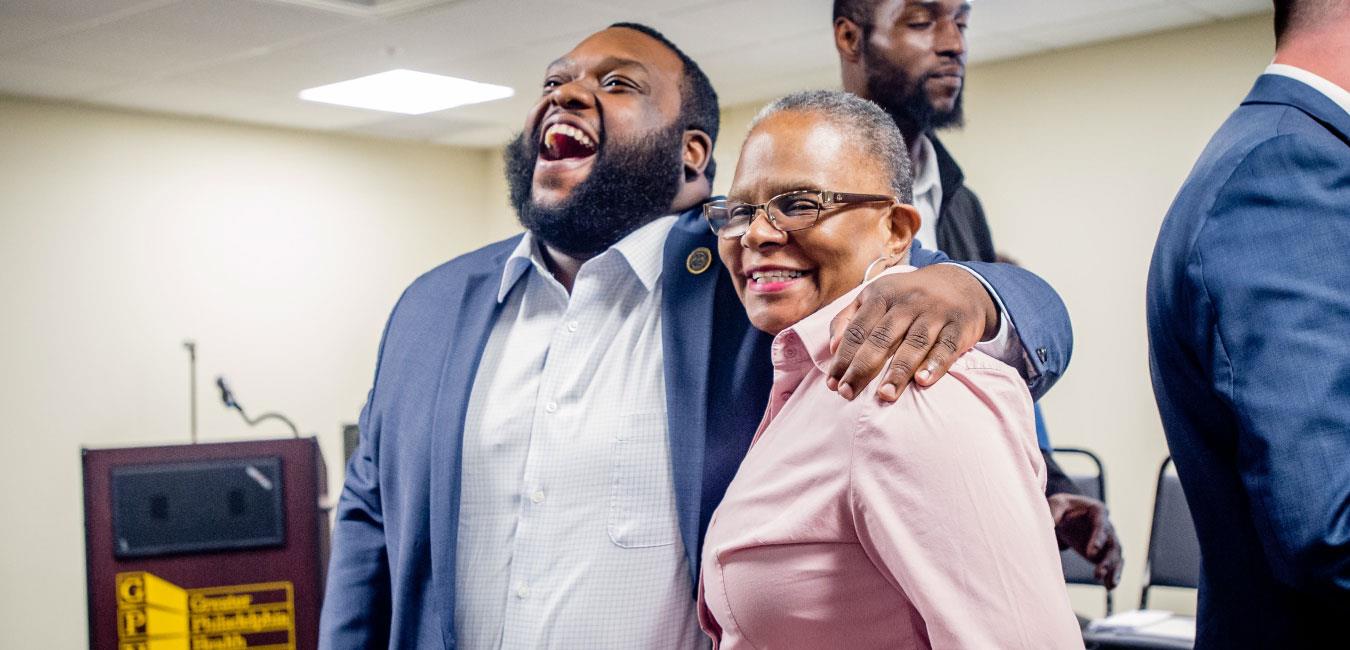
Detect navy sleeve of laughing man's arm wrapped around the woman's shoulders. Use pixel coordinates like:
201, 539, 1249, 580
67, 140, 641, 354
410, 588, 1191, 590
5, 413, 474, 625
910, 246, 1073, 399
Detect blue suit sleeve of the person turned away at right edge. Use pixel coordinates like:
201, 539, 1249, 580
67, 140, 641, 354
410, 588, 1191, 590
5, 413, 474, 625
1188, 134, 1350, 596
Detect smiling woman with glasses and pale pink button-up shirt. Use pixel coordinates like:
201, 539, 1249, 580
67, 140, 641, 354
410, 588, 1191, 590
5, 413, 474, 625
699, 91, 1083, 650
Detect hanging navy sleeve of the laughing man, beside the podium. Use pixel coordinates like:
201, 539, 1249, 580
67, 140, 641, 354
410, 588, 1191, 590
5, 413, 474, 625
319, 307, 397, 650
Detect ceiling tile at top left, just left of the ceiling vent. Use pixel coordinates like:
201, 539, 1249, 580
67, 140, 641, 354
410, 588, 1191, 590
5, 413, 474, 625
18, 0, 358, 77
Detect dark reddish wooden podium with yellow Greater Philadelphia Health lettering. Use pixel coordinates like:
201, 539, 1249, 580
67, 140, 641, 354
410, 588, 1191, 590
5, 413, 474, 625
82, 438, 328, 650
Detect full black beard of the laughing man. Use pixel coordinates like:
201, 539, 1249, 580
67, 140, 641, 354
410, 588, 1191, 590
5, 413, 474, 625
506, 122, 684, 259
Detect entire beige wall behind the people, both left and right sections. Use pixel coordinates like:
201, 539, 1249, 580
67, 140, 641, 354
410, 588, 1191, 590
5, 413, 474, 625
0, 11, 1270, 647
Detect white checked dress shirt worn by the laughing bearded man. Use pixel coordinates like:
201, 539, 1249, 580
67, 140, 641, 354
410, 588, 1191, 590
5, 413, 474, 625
447, 216, 707, 650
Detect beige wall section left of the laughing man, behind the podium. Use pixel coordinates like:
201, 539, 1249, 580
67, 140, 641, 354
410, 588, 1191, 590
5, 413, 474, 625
0, 99, 517, 649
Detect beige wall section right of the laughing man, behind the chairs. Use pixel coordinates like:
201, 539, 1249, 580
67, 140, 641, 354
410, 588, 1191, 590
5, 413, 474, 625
717, 15, 1273, 612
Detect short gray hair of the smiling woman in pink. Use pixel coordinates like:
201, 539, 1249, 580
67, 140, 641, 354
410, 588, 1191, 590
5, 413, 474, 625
751, 91, 914, 203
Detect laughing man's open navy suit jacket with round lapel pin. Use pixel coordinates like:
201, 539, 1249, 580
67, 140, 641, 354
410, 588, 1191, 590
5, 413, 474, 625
320, 209, 1073, 649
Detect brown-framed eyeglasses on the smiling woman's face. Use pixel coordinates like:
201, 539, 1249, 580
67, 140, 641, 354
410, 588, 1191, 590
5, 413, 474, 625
703, 189, 896, 239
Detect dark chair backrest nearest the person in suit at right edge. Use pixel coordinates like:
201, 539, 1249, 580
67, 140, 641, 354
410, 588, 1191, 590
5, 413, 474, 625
1139, 457, 1200, 608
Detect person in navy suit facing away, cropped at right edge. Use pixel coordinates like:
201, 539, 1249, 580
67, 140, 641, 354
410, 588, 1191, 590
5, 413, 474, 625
1148, 0, 1350, 649
